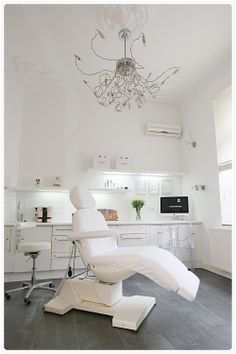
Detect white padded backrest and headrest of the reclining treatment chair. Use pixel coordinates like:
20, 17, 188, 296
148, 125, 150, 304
70, 186, 118, 263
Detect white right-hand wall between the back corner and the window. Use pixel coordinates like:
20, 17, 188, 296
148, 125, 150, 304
179, 60, 232, 264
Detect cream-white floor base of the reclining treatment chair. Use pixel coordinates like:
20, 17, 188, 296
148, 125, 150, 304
44, 278, 156, 331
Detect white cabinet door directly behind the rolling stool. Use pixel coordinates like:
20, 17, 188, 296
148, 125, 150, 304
14, 226, 52, 272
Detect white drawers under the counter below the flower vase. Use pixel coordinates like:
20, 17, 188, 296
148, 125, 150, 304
118, 225, 147, 247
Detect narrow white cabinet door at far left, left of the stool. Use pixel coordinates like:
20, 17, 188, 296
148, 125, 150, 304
4, 226, 15, 273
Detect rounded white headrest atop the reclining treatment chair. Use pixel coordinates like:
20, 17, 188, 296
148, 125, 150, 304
70, 186, 96, 209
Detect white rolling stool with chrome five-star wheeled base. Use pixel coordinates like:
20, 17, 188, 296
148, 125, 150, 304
5, 224, 56, 305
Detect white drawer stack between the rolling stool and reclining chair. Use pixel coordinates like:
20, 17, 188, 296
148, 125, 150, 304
51, 225, 84, 270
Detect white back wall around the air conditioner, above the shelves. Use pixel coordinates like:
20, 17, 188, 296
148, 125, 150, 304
12, 83, 180, 188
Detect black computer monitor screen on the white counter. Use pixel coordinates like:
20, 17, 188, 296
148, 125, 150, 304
160, 196, 189, 214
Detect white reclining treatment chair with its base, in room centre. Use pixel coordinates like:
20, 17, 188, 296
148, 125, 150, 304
44, 186, 199, 330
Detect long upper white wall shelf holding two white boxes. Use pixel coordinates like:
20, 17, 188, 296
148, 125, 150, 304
87, 168, 186, 177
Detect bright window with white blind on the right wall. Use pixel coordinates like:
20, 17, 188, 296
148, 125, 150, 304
214, 87, 233, 225
